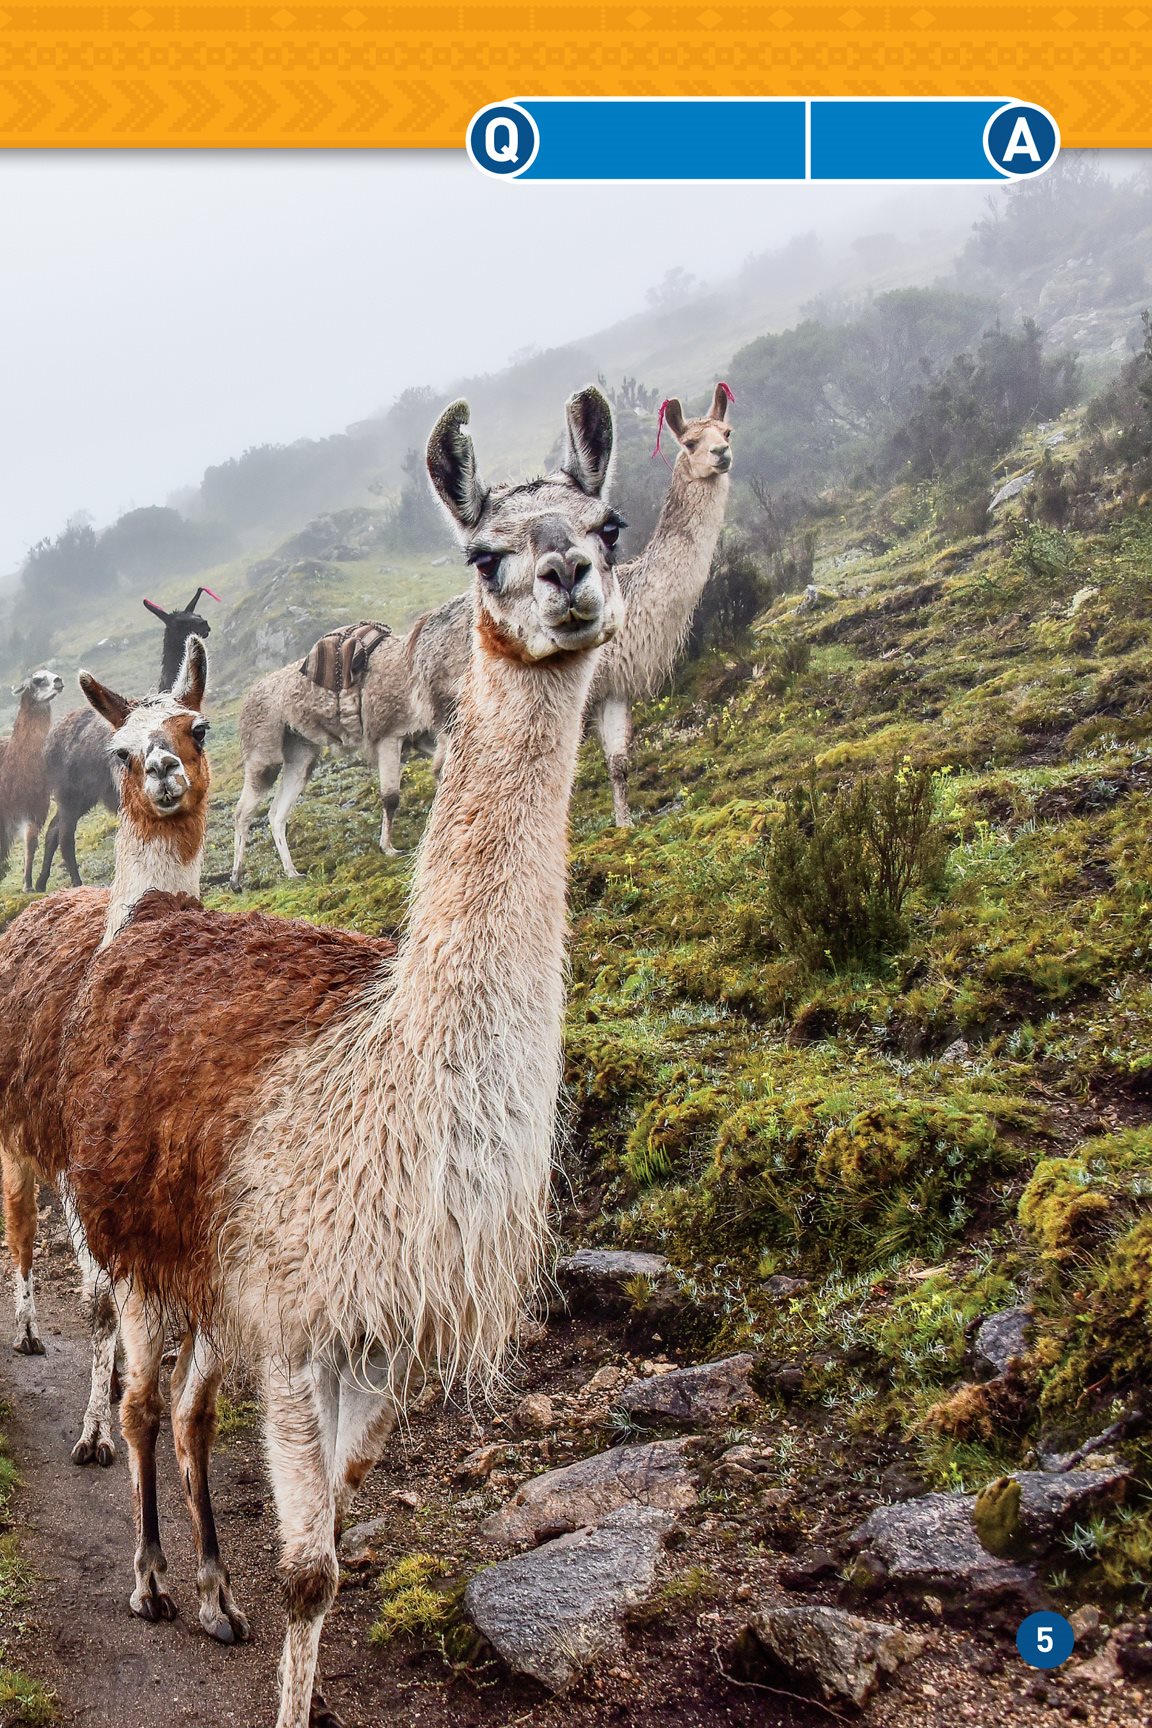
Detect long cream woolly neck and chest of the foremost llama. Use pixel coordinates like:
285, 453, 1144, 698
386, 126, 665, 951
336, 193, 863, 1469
294, 622, 596, 1377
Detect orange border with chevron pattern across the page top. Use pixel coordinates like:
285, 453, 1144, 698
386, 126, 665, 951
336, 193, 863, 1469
0, 0, 1152, 149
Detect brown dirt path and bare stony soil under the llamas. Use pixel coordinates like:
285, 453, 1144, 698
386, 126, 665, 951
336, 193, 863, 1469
0, 1220, 1152, 1728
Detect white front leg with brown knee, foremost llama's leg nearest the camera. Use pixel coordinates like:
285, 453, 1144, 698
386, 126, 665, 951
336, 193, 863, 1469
264, 1362, 342, 1728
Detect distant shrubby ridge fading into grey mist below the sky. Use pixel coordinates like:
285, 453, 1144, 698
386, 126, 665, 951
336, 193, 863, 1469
0, 156, 1152, 715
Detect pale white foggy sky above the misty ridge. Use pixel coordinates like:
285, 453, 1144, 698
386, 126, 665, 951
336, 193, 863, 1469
0, 150, 994, 572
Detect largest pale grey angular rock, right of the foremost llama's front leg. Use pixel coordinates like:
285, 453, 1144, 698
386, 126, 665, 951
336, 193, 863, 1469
465, 1505, 674, 1692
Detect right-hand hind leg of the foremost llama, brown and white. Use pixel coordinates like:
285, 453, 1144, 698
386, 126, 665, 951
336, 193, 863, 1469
173, 1332, 250, 1643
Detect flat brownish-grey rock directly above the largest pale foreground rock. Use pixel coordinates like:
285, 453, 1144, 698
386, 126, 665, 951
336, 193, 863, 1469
482, 1439, 696, 1548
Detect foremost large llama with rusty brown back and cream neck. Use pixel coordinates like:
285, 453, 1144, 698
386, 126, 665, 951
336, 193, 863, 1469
40, 389, 620, 1728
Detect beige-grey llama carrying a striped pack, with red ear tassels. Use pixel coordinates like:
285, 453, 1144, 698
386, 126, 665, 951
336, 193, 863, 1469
231, 384, 732, 892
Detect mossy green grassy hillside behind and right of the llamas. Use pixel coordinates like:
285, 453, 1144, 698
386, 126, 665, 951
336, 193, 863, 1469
11, 392, 1152, 1602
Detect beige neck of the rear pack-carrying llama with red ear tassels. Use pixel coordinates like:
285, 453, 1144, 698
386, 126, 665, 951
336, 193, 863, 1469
592, 454, 731, 702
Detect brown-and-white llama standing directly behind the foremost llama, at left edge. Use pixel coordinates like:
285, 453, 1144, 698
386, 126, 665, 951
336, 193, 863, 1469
0, 636, 211, 1486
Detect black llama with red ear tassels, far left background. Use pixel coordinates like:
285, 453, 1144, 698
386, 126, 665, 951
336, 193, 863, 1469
36, 588, 219, 893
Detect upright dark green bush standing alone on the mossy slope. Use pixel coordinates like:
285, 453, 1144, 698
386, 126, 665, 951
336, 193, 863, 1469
765, 764, 945, 969
